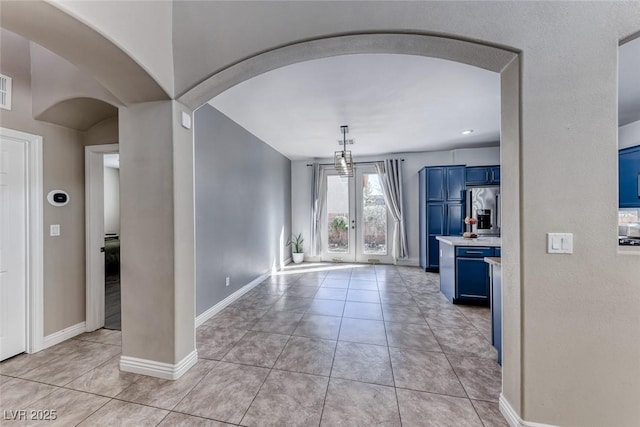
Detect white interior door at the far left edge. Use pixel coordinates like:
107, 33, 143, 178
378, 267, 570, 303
0, 138, 27, 360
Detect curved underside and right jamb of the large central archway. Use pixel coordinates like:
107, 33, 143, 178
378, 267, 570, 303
178, 33, 522, 422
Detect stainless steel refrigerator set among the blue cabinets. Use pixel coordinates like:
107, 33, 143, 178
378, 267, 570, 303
466, 186, 500, 236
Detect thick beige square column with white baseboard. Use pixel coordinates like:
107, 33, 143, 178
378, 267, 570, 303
119, 101, 197, 379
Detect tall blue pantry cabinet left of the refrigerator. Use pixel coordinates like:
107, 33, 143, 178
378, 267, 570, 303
418, 166, 466, 271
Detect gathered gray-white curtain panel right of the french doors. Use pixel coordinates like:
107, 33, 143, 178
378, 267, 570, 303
376, 159, 409, 259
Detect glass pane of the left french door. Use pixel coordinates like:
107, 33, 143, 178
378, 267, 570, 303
327, 175, 349, 253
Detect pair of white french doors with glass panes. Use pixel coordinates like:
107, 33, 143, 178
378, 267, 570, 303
321, 165, 393, 264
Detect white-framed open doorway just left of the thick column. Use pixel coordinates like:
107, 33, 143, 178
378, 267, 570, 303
85, 144, 121, 332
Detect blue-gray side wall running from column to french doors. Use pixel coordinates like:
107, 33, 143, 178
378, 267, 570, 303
194, 104, 291, 315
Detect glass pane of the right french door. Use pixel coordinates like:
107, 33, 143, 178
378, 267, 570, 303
362, 173, 387, 255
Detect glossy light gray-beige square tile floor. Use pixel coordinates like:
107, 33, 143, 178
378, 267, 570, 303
0, 264, 507, 427
